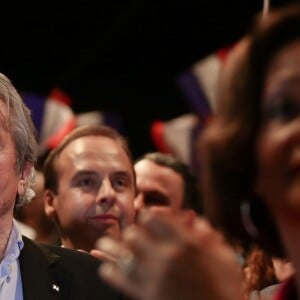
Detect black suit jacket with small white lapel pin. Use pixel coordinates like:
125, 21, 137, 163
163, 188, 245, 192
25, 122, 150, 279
19, 237, 121, 300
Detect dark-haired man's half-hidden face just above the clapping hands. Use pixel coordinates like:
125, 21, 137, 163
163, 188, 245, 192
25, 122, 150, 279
134, 152, 203, 215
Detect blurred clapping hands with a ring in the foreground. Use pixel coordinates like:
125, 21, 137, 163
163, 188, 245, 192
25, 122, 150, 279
97, 211, 243, 300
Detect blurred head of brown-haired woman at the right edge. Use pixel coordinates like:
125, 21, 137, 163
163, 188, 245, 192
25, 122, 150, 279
201, 7, 300, 255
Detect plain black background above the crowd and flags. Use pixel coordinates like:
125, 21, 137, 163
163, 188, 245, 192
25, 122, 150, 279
0, 0, 291, 156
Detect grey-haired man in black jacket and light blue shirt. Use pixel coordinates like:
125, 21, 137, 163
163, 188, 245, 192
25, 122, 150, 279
0, 74, 119, 300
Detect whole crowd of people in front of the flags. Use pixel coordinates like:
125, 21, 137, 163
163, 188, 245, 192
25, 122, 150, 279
0, 5, 300, 300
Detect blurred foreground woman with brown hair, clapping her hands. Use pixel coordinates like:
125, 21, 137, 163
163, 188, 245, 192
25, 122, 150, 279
98, 5, 300, 300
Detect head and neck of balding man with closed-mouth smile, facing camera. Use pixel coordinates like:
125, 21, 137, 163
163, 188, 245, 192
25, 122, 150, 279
43, 125, 136, 252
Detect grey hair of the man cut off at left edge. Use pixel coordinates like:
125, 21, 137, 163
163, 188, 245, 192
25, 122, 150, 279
0, 73, 38, 207
